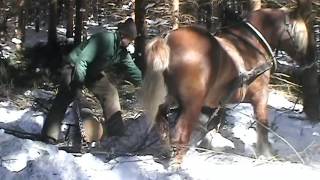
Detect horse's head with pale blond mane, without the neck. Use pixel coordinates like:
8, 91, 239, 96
277, 0, 315, 65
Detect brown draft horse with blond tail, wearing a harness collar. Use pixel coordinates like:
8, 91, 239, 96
143, 0, 311, 164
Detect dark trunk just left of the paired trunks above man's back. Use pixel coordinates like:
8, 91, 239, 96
48, 0, 58, 47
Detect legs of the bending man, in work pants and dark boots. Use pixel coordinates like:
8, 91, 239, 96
42, 64, 123, 140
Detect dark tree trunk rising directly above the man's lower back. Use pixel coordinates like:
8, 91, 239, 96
74, 0, 84, 45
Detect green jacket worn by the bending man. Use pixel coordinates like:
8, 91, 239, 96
68, 32, 142, 84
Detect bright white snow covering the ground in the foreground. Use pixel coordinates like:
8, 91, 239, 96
0, 90, 320, 180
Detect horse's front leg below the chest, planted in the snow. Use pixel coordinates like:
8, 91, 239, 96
252, 91, 272, 158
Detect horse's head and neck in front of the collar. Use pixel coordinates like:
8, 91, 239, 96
248, 0, 314, 65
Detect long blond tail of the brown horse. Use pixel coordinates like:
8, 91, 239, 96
142, 38, 170, 127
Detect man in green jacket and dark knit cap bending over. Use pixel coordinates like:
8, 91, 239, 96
42, 18, 142, 144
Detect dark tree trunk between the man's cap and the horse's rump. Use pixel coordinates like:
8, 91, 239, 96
135, 0, 147, 74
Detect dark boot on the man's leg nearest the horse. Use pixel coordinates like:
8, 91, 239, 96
104, 111, 125, 137
